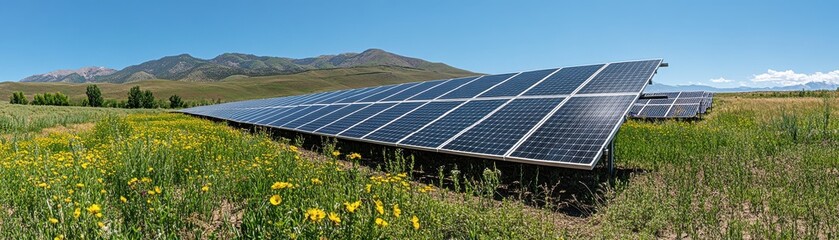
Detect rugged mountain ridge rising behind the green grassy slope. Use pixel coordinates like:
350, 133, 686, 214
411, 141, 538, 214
21, 49, 471, 83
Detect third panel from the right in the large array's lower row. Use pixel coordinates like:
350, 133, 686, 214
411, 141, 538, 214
399, 100, 507, 148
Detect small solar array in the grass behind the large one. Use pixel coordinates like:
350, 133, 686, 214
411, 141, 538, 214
629, 91, 714, 119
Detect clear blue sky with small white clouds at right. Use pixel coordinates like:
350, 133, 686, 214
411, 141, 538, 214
0, 0, 839, 87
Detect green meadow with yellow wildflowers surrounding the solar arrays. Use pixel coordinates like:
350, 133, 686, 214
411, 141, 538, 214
0, 94, 839, 239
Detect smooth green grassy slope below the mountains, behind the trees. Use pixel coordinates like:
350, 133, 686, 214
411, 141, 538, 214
0, 66, 474, 101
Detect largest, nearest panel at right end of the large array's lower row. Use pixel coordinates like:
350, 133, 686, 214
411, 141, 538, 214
510, 96, 636, 164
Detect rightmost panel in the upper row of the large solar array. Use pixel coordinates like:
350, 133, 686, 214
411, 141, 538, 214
578, 60, 661, 94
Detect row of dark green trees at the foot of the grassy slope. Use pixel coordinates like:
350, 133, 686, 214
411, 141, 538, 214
9, 84, 213, 108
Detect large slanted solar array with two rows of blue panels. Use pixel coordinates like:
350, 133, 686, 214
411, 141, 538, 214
182, 59, 662, 169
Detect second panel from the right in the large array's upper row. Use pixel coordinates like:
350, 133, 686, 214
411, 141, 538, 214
524, 64, 604, 96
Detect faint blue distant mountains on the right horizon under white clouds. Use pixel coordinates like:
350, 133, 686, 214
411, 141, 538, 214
644, 82, 839, 92
